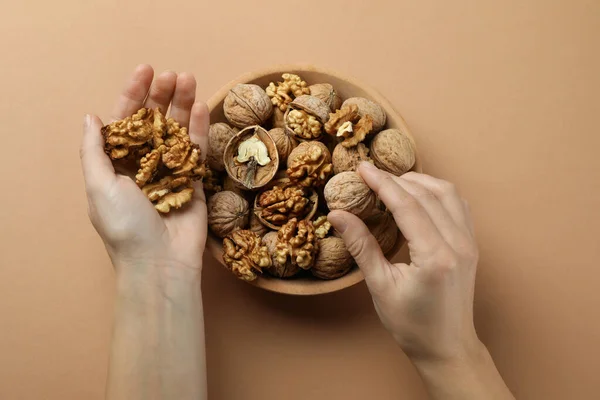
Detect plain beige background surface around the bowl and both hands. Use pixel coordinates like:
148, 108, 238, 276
0, 0, 600, 400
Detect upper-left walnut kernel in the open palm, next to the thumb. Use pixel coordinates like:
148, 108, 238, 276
101, 108, 154, 160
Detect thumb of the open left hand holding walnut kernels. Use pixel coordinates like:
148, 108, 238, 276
79, 115, 115, 193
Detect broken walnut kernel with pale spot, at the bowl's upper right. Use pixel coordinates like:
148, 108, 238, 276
325, 104, 373, 147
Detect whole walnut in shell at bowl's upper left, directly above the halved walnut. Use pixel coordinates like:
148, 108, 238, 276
223, 83, 273, 128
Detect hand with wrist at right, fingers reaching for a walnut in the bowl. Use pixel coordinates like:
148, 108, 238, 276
328, 163, 513, 400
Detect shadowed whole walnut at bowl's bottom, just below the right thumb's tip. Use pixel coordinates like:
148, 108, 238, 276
310, 236, 354, 279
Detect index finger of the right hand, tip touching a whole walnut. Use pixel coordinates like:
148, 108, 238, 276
358, 162, 442, 252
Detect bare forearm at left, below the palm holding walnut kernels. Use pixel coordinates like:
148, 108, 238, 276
107, 265, 206, 400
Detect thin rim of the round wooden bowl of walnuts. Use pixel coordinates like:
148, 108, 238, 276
206, 64, 422, 296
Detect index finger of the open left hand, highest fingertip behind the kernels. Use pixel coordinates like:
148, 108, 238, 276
112, 64, 154, 120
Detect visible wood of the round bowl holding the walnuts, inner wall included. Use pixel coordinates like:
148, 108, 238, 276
207, 65, 421, 295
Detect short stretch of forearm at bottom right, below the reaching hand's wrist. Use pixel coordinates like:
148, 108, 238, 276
413, 344, 514, 400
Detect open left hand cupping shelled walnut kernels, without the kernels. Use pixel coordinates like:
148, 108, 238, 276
80, 65, 209, 271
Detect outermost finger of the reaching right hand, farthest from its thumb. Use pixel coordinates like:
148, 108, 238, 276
399, 172, 469, 229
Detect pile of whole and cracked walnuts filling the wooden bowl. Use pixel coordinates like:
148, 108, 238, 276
203, 73, 416, 281
